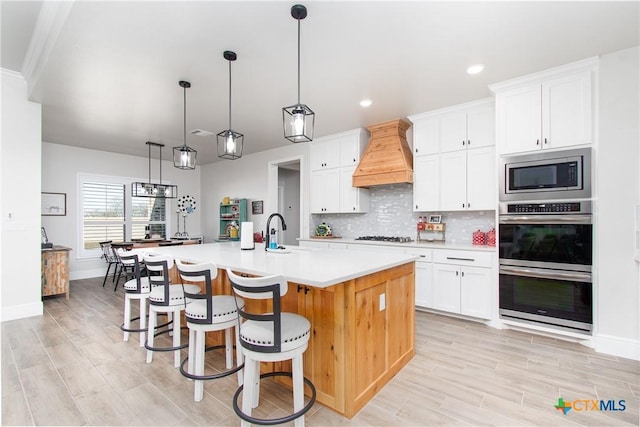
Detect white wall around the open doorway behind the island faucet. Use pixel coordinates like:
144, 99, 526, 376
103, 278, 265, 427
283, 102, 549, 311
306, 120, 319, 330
202, 143, 309, 242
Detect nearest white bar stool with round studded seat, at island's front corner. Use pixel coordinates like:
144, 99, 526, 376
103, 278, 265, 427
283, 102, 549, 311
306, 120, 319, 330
227, 269, 316, 427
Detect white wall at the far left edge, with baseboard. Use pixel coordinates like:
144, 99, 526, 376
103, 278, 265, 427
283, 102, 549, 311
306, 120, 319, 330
0, 70, 43, 322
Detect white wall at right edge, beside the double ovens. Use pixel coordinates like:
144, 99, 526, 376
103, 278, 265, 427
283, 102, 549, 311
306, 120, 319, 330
594, 47, 640, 359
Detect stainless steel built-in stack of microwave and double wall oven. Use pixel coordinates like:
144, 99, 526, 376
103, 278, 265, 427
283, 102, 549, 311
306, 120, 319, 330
498, 149, 593, 333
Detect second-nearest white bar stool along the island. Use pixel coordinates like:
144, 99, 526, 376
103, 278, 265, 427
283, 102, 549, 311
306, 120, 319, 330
176, 260, 244, 402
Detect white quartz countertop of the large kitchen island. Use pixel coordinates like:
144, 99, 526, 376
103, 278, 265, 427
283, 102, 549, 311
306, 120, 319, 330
148, 242, 417, 288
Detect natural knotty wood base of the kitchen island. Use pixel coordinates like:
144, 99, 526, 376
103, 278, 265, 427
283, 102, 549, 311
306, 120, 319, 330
186, 262, 415, 418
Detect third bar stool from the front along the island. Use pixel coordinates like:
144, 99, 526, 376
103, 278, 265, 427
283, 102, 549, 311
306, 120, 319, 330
144, 255, 200, 368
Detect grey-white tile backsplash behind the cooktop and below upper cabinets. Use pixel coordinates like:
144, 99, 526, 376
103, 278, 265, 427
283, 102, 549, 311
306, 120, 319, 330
309, 184, 495, 244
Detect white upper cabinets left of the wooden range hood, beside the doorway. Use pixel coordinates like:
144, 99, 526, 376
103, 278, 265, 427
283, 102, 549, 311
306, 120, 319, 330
310, 129, 369, 214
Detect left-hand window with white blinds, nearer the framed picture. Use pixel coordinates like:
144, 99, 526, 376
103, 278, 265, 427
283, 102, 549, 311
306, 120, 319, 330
82, 182, 126, 250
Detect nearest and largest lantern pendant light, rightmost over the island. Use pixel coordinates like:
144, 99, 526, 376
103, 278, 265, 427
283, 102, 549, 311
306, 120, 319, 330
282, 4, 315, 142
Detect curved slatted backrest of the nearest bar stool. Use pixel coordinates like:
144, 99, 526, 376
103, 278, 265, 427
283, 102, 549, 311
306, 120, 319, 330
227, 269, 288, 353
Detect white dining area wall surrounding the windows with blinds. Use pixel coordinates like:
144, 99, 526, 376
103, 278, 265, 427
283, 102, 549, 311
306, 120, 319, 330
38, 141, 203, 280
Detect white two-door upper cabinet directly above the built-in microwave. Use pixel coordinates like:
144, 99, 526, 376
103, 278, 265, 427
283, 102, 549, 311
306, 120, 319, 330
491, 59, 597, 154
